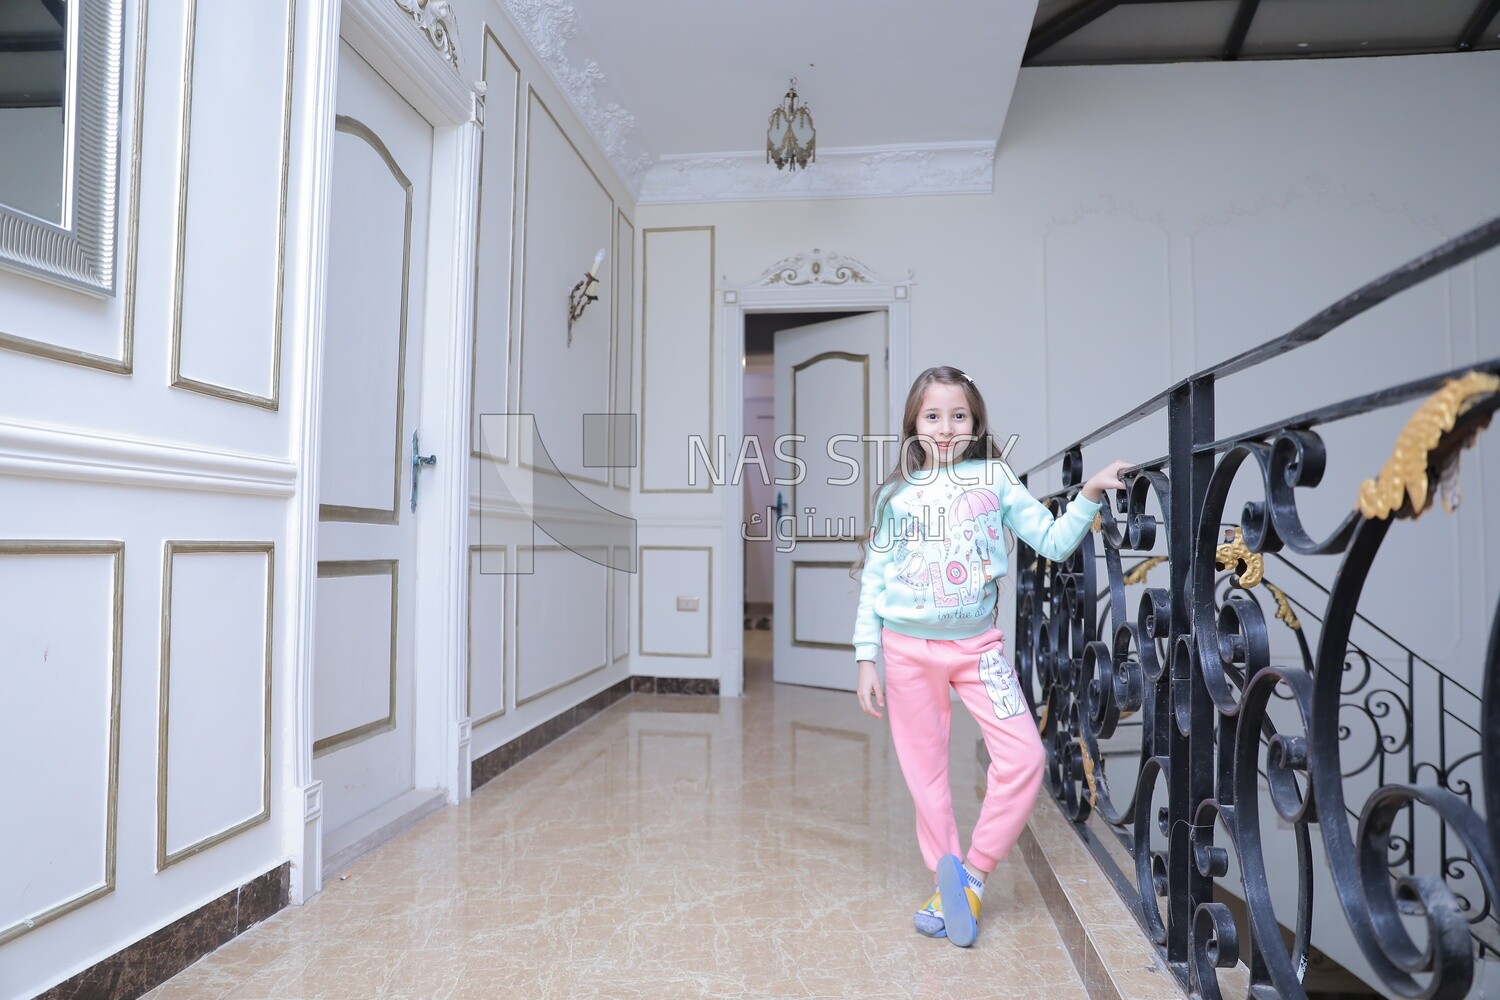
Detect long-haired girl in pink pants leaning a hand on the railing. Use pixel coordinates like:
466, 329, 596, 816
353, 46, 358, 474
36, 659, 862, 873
854, 366, 1130, 948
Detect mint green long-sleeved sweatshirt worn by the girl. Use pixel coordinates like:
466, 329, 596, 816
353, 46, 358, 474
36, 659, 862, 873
854, 459, 1103, 660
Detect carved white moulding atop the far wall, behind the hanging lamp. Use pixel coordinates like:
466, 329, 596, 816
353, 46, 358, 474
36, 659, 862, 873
639, 139, 995, 205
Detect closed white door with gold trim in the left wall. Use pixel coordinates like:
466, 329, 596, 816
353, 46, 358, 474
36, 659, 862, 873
314, 42, 432, 855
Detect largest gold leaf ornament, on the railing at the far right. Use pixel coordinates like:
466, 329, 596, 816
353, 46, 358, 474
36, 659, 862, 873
1358, 372, 1500, 519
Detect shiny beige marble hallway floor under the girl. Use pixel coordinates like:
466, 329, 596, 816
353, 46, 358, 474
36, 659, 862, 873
149, 633, 1085, 1000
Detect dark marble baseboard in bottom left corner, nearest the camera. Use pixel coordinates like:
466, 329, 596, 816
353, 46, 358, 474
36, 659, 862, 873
39, 862, 291, 1000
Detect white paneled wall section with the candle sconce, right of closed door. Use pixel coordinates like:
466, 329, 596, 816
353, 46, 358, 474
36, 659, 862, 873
455, 0, 639, 759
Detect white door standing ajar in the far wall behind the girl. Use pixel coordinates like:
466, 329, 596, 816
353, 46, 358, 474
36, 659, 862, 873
764, 312, 896, 691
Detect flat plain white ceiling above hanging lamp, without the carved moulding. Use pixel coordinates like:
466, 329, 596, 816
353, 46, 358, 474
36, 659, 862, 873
573, 0, 1037, 156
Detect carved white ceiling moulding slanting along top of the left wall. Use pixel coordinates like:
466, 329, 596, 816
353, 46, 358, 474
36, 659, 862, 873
503, 0, 654, 195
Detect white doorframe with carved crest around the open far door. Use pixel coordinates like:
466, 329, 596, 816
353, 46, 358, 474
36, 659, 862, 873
714, 250, 915, 697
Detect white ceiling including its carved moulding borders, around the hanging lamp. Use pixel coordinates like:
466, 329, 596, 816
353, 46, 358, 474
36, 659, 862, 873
503, 0, 1037, 202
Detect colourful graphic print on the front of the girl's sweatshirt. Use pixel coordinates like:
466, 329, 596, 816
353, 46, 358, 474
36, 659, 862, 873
893, 484, 1004, 621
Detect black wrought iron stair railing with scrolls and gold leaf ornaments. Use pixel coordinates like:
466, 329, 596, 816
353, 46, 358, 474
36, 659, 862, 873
1016, 219, 1500, 999
